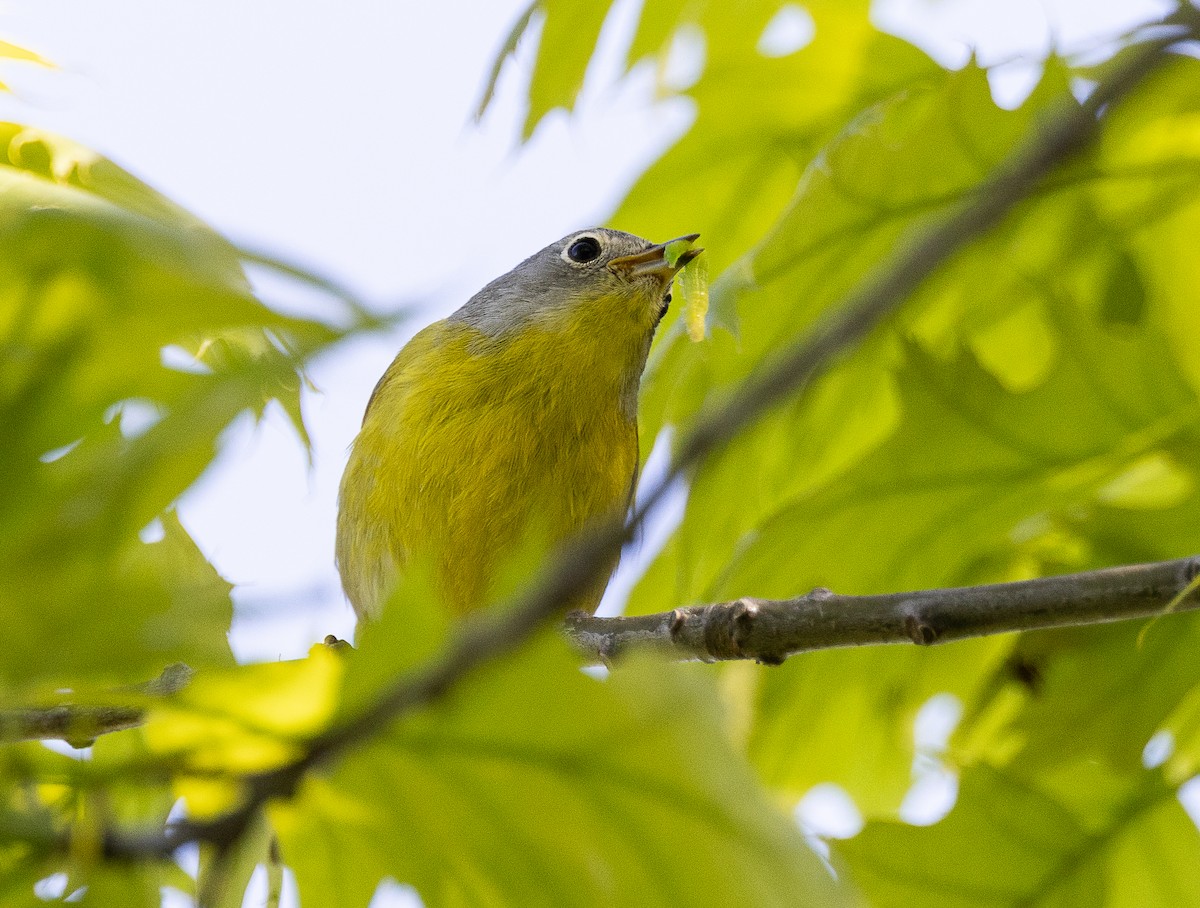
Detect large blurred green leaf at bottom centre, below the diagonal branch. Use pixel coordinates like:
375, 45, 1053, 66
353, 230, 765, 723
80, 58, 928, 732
271, 636, 841, 906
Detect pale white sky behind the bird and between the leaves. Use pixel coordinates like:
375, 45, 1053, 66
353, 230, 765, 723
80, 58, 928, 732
0, 0, 1185, 902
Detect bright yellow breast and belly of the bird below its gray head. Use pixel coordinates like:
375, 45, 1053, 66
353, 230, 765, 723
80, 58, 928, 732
337, 301, 649, 617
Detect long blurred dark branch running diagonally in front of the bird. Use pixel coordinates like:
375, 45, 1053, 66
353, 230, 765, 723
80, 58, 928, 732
21, 7, 1200, 860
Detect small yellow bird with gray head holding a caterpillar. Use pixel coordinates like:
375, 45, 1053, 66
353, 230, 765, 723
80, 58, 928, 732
336, 227, 701, 623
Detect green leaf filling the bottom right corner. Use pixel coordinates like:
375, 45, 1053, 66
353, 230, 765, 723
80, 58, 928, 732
834, 765, 1200, 908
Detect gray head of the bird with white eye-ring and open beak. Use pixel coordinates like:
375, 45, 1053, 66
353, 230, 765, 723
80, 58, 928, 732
450, 227, 700, 337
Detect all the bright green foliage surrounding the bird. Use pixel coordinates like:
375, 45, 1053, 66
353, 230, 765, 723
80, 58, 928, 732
0, 0, 1200, 907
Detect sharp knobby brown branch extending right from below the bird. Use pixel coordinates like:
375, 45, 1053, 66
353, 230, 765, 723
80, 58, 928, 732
566, 557, 1200, 665
